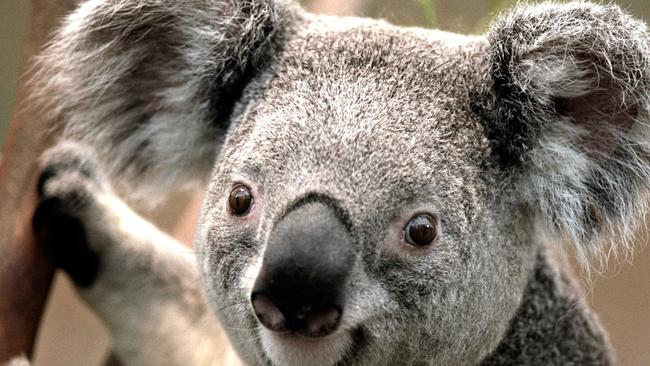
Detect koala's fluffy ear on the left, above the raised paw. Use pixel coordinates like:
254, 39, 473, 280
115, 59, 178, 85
32, 0, 296, 203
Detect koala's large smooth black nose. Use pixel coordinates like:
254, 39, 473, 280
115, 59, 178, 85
251, 202, 354, 337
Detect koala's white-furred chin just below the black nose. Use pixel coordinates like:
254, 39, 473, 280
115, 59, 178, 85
260, 329, 352, 366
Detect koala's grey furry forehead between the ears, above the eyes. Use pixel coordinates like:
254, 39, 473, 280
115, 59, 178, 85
222, 17, 487, 223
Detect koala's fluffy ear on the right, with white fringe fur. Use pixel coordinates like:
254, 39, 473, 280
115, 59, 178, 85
481, 2, 650, 260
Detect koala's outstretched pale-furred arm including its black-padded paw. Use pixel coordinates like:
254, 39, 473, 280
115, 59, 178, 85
34, 144, 235, 365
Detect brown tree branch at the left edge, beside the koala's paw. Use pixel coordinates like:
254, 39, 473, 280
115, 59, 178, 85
0, 0, 74, 362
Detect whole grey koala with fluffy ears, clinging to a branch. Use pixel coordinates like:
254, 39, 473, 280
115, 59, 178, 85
33, 0, 650, 366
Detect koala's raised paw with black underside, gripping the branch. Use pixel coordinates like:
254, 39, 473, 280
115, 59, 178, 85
32, 142, 104, 287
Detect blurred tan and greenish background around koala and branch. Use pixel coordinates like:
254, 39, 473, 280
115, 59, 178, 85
0, 0, 650, 366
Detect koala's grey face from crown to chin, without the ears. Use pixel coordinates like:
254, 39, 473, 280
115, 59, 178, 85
197, 23, 534, 365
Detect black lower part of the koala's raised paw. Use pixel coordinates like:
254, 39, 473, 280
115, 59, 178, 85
32, 197, 100, 287
